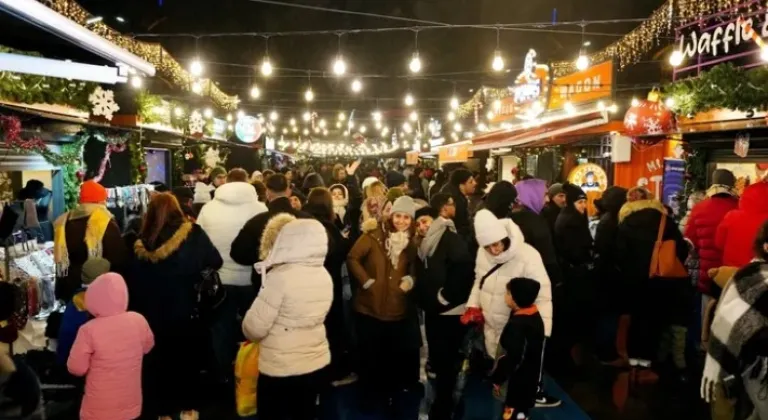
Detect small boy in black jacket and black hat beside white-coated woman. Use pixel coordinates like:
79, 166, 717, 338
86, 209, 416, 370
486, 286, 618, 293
491, 277, 544, 420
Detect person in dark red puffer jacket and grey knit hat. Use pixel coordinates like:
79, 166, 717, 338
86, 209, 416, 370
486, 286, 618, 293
683, 169, 739, 298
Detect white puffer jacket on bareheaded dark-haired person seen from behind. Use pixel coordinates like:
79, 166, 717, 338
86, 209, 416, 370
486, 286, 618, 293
197, 182, 267, 286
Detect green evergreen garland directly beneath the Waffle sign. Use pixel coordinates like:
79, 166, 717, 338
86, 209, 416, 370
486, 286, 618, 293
664, 63, 768, 115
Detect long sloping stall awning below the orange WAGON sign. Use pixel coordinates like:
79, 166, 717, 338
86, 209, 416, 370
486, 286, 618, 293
472, 111, 610, 150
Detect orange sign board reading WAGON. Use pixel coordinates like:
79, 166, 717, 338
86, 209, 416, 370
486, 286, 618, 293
548, 61, 613, 110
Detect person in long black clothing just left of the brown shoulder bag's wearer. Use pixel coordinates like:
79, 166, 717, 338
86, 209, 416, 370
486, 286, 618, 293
595, 186, 628, 364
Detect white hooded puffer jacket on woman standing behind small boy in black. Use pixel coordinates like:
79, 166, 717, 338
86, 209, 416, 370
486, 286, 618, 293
467, 210, 552, 358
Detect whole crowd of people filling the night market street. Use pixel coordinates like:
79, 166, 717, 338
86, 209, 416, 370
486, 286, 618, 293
1, 161, 768, 420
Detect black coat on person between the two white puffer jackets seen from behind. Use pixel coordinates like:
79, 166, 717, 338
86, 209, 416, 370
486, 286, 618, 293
229, 197, 312, 293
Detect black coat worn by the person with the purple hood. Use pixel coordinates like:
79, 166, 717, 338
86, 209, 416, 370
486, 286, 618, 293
509, 207, 562, 286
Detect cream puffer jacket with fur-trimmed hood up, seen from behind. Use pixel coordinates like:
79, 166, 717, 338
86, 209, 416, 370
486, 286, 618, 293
243, 214, 333, 377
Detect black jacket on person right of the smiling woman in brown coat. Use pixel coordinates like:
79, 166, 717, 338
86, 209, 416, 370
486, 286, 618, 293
415, 226, 475, 314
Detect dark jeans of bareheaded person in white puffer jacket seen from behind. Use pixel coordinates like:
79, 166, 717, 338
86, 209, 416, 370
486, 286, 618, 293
211, 285, 256, 382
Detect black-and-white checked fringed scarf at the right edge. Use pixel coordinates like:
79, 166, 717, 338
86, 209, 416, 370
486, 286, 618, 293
702, 261, 768, 390
